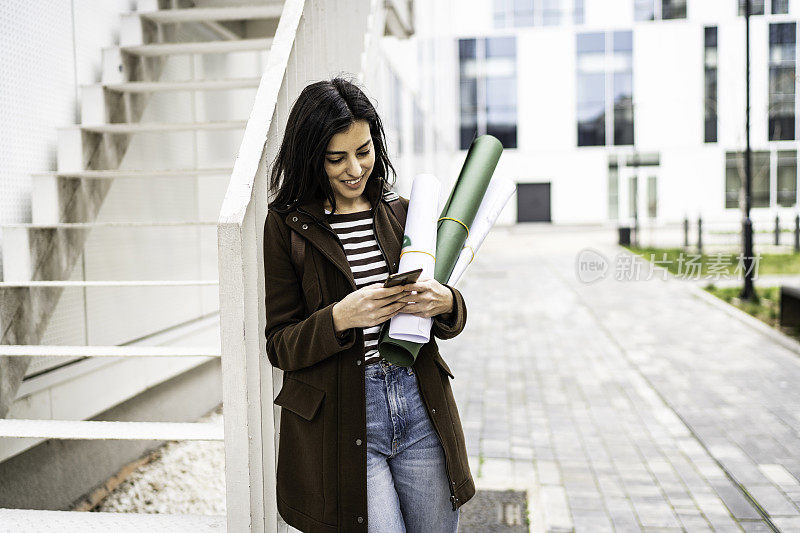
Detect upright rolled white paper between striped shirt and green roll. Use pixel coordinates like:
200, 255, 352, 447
389, 174, 441, 344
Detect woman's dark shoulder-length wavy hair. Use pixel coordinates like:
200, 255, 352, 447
270, 77, 397, 212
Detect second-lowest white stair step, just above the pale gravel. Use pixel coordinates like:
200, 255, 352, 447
0, 418, 225, 441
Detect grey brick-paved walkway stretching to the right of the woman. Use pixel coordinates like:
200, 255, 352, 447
441, 225, 800, 533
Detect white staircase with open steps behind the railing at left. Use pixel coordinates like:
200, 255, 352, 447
0, 0, 283, 532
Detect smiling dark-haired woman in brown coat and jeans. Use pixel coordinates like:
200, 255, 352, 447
264, 78, 475, 533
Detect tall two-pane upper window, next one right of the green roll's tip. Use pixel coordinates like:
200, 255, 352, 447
576, 31, 634, 146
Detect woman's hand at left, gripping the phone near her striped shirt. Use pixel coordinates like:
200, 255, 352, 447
333, 283, 411, 333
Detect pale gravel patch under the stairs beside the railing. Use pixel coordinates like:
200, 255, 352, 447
93, 405, 225, 515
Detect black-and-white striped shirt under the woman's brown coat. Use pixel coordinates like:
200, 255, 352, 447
325, 209, 389, 365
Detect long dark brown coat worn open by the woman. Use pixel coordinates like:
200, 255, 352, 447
264, 181, 475, 533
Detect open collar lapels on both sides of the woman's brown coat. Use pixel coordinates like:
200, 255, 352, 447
284, 183, 404, 290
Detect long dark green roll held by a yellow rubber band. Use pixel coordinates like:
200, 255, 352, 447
378, 135, 503, 366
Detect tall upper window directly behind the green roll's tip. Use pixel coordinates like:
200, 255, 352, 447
459, 37, 517, 150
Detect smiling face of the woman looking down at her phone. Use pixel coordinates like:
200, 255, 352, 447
324, 120, 375, 205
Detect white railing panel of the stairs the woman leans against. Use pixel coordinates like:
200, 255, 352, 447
217, 0, 375, 532
